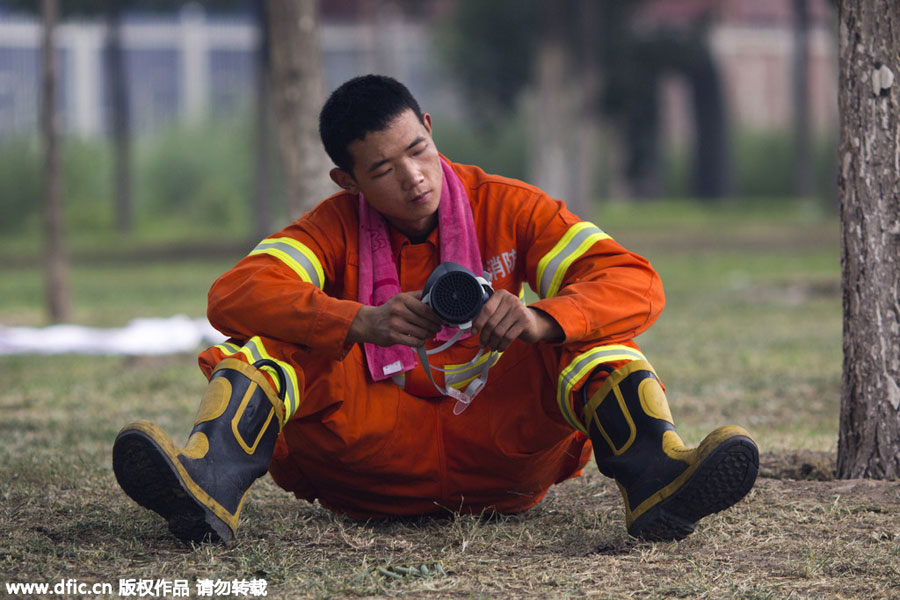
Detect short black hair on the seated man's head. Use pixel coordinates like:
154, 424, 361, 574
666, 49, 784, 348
319, 75, 424, 173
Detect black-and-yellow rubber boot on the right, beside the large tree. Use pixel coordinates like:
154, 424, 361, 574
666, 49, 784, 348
583, 361, 759, 540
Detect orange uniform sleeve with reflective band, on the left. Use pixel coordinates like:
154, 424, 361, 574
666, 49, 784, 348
207, 202, 361, 359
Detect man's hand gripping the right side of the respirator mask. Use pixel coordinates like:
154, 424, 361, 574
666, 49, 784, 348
472, 290, 565, 352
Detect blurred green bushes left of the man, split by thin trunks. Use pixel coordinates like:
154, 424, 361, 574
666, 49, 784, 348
0, 119, 252, 239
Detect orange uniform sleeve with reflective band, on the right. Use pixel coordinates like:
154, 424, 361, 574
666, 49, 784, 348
522, 190, 665, 343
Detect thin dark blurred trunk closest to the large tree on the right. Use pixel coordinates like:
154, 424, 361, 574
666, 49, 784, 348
791, 0, 813, 197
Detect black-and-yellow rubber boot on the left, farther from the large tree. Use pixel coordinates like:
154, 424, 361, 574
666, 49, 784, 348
113, 358, 284, 542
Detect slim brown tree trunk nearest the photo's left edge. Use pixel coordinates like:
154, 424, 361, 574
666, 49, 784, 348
41, 0, 69, 323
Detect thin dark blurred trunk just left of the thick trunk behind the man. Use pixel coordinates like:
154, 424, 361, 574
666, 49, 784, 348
251, 0, 275, 239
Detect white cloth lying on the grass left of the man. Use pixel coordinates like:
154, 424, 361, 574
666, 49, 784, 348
0, 315, 225, 355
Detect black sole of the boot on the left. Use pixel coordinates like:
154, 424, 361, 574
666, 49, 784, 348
113, 430, 232, 543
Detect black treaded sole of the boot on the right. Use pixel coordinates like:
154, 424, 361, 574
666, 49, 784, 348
628, 436, 759, 541
